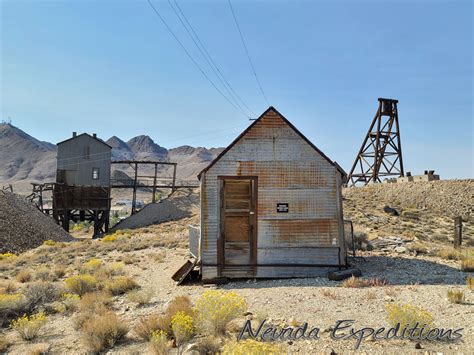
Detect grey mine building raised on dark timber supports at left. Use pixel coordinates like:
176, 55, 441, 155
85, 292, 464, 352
53, 132, 112, 236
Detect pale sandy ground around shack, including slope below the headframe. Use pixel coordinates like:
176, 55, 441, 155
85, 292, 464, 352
0, 185, 474, 354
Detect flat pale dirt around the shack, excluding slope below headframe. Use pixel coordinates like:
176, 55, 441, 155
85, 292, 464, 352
2, 217, 474, 354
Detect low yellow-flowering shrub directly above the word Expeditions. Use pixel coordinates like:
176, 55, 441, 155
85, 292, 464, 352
386, 303, 434, 330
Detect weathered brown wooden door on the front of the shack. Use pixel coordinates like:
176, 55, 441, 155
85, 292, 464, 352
221, 178, 257, 277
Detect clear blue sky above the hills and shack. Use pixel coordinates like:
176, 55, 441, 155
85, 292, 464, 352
0, 0, 474, 178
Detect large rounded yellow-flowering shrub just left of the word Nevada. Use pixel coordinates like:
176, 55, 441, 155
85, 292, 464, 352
195, 290, 247, 334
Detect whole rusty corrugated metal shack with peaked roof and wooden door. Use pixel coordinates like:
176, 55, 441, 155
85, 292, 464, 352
199, 107, 346, 281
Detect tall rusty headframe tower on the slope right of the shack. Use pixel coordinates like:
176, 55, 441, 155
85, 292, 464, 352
347, 98, 404, 186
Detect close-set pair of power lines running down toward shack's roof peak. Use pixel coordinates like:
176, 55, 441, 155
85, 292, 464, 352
172, 0, 256, 116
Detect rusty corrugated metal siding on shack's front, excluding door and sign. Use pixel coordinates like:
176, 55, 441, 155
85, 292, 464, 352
201, 112, 344, 278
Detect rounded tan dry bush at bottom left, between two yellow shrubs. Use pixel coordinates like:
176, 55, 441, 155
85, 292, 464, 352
82, 312, 129, 353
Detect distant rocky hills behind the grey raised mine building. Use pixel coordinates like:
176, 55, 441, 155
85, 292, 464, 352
0, 123, 223, 192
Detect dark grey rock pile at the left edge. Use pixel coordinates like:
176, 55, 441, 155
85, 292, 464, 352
0, 191, 74, 253
